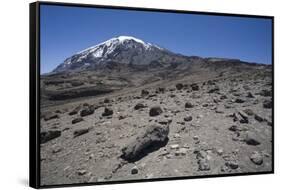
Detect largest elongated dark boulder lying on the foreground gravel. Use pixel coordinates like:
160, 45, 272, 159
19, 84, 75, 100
121, 125, 169, 162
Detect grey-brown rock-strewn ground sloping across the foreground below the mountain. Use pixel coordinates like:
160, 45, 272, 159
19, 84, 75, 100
41, 65, 273, 185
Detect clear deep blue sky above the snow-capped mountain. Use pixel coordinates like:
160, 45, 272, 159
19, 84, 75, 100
40, 5, 272, 73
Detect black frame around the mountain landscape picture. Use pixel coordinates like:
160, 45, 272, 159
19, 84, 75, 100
29, 1, 274, 188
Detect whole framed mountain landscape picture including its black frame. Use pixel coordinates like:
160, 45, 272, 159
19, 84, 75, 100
30, 2, 274, 188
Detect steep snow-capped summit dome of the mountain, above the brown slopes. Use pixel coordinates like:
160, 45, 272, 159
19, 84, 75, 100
53, 36, 184, 72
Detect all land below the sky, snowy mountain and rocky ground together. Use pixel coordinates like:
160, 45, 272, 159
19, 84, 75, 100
40, 37, 273, 185
